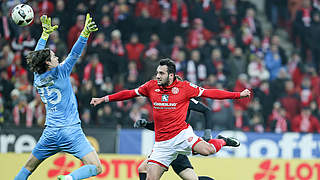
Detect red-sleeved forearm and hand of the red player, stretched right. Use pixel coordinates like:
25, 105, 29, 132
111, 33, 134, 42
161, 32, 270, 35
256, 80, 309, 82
201, 89, 251, 99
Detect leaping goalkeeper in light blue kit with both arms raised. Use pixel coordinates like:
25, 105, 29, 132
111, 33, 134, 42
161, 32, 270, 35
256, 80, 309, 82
15, 14, 102, 180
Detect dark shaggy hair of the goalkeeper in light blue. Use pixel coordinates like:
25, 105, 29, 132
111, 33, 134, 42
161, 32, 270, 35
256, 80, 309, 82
26, 48, 51, 74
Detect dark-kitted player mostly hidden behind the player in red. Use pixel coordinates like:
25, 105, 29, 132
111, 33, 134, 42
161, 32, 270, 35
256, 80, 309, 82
134, 98, 212, 180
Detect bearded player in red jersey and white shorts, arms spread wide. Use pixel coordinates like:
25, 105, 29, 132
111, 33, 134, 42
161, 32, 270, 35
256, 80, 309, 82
90, 59, 250, 180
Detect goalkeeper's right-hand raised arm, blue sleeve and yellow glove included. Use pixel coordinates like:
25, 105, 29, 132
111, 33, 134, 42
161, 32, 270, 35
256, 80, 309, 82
62, 13, 98, 74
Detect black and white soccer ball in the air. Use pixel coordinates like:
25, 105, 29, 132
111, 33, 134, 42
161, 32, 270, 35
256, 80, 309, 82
11, 4, 34, 26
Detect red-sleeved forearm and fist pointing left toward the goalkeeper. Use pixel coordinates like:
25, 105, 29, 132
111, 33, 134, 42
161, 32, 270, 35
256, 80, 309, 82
90, 89, 139, 106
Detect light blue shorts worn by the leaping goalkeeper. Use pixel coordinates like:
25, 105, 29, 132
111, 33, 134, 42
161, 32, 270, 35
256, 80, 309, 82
32, 123, 94, 160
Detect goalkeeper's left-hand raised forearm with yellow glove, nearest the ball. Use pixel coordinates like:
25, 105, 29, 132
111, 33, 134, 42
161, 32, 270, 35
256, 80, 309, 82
35, 15, 58, 51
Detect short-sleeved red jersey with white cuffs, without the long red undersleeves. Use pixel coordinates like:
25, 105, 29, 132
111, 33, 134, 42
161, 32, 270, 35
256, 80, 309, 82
136, 80, 203, 141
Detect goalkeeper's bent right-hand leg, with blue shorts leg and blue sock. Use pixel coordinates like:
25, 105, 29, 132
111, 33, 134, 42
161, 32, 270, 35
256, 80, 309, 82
58, 125, 102, 180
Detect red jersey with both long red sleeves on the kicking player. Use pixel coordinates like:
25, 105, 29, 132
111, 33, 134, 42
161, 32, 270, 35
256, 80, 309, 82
104, 80, 240, 142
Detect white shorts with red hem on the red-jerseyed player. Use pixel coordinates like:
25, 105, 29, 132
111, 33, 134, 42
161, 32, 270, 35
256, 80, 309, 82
148, 126, 201, 169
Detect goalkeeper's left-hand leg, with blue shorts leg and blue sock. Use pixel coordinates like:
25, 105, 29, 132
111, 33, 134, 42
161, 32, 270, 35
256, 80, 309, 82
14, 128, 59, 180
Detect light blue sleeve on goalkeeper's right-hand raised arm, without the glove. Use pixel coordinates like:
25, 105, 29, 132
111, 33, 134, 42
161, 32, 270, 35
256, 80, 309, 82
59, 36, 88, 77
